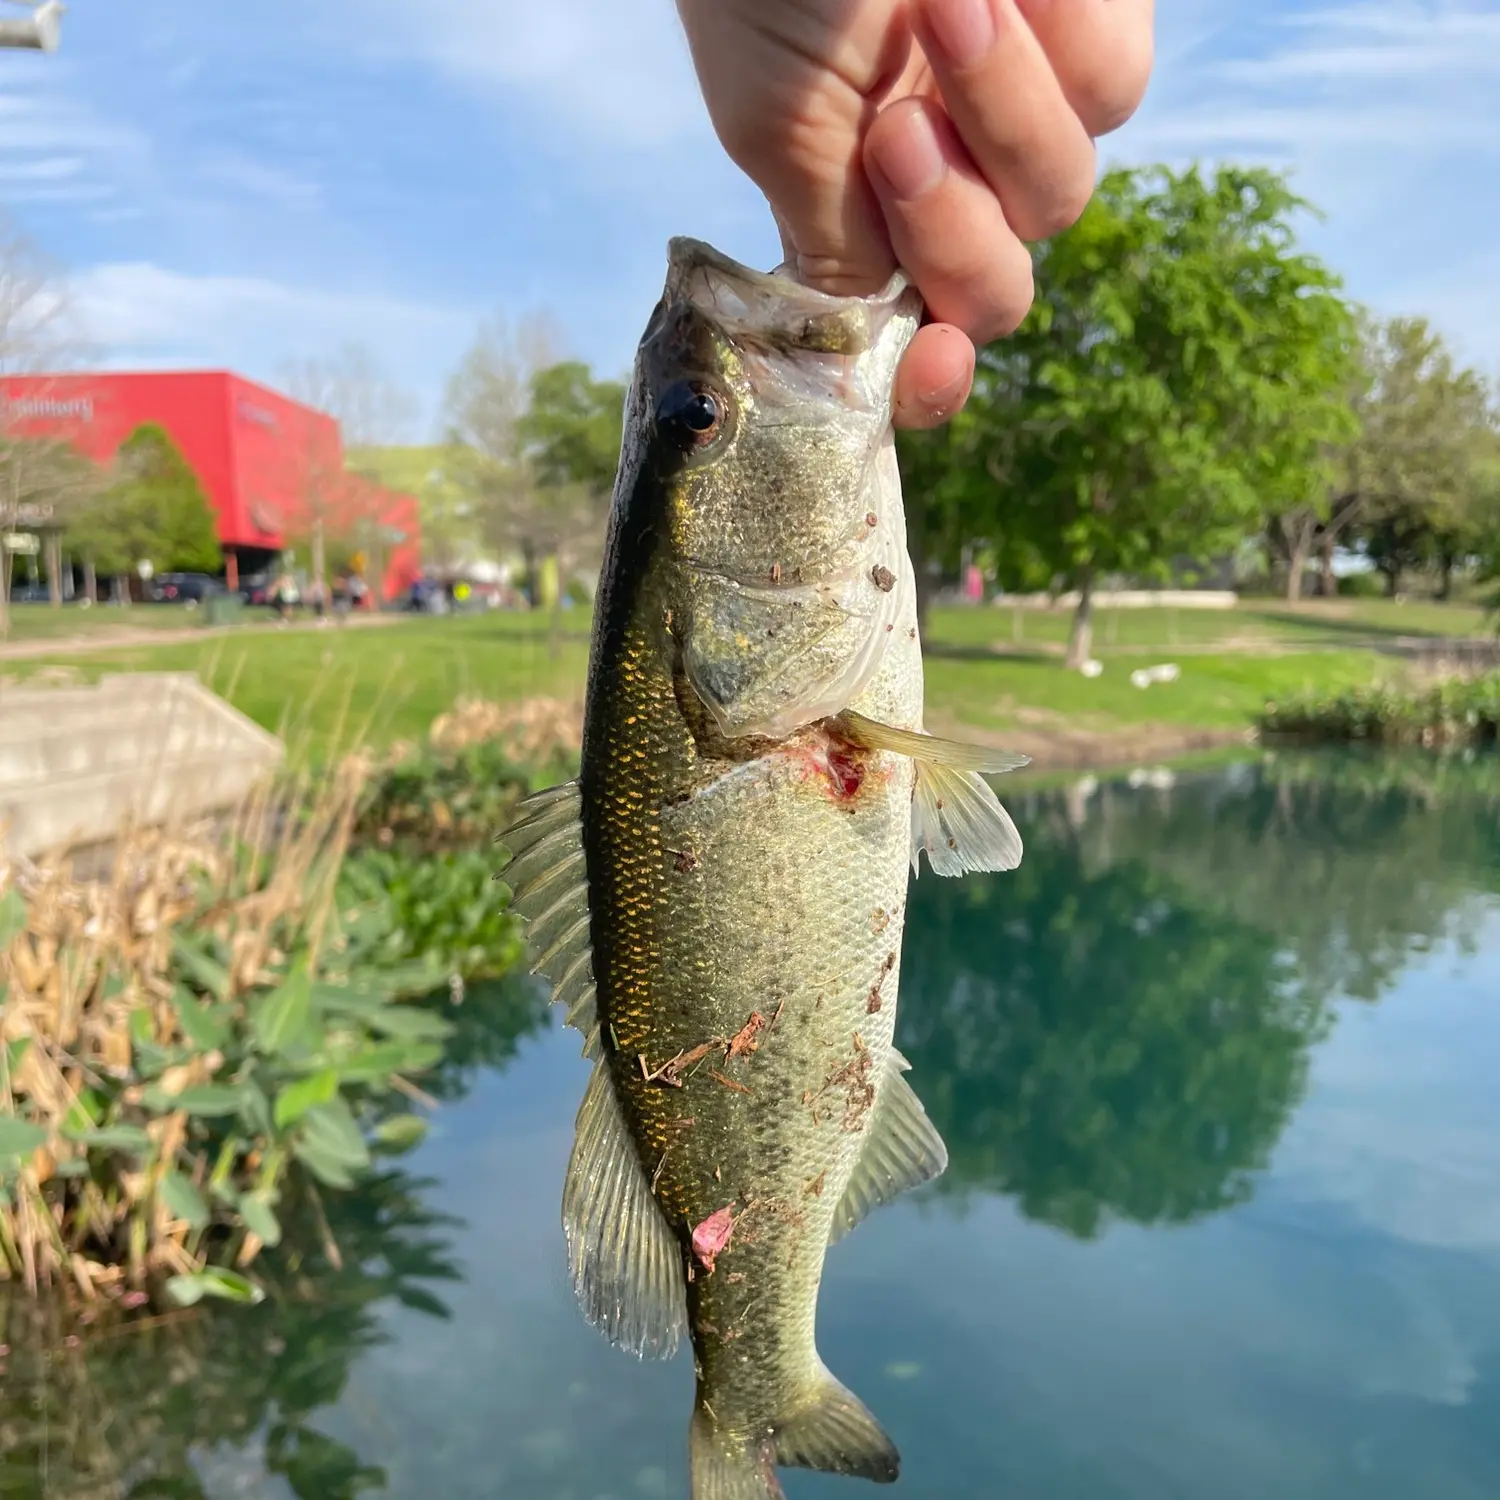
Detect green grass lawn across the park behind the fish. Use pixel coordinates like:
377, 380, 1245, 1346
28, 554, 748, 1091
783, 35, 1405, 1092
0, 600, 1452, 758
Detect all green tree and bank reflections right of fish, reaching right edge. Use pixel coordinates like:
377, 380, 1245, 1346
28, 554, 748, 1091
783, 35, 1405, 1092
899, 756, 1500, 1238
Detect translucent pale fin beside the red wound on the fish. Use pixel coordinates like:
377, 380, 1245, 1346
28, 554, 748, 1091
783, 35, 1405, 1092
840, 711, 1031, 875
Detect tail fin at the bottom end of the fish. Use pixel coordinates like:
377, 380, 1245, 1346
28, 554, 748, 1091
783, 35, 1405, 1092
689, 1370, 902, 1500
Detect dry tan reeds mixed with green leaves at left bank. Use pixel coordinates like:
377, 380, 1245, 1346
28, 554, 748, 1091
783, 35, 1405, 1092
0, 756, 393, 1298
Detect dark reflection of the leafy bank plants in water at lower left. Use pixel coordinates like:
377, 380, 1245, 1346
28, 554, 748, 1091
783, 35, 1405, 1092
0, 980, 546, 1500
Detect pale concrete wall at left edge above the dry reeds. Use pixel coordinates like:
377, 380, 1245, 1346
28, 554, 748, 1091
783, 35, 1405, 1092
0, 672, 284, 858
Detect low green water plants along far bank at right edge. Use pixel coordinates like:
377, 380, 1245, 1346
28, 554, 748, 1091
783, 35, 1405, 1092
1260, 672, 1500, 747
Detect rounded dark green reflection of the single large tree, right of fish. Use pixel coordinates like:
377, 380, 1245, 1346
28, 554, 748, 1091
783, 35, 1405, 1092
899, 831, 1325, 1238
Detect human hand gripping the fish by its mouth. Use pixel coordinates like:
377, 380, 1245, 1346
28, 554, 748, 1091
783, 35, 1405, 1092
677, 0, 1154, 428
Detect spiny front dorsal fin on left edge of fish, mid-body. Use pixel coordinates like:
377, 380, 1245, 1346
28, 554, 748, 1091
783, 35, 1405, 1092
500, 782, 599, 1056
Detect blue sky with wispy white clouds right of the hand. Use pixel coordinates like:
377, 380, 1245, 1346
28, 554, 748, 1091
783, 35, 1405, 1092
1103, 0, 1500, 369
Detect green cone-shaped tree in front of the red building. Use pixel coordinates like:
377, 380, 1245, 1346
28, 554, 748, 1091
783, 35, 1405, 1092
69, 423, 221, 575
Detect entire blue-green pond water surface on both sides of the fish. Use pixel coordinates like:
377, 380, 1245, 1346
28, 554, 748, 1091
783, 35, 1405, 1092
0, 756, 1500, 1500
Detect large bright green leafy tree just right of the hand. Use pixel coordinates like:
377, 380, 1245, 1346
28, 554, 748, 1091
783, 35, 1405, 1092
908, 168, 1355, 666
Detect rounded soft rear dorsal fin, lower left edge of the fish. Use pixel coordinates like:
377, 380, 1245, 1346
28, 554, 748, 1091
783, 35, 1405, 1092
563, 1058, 687, 1359
